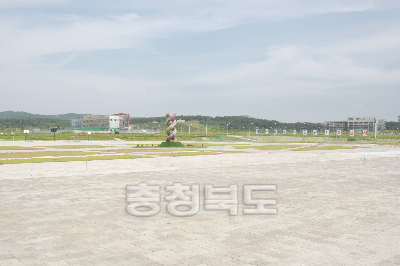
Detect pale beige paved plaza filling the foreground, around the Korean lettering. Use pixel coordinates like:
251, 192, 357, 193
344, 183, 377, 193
0, 142, 400, 265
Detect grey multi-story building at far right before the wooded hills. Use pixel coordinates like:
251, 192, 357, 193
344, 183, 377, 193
325, 117, 386, 131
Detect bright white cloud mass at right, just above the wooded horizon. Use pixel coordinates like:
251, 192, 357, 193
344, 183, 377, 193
171, 36, 400, 98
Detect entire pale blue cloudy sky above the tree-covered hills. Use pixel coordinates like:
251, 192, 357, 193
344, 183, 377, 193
0, 0, 400, 122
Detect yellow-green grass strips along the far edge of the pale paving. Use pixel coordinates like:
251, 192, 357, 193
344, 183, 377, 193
0, 143, 369, 164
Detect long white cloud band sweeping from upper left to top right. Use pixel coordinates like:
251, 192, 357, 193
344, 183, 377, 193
0, 0, 400, 63
